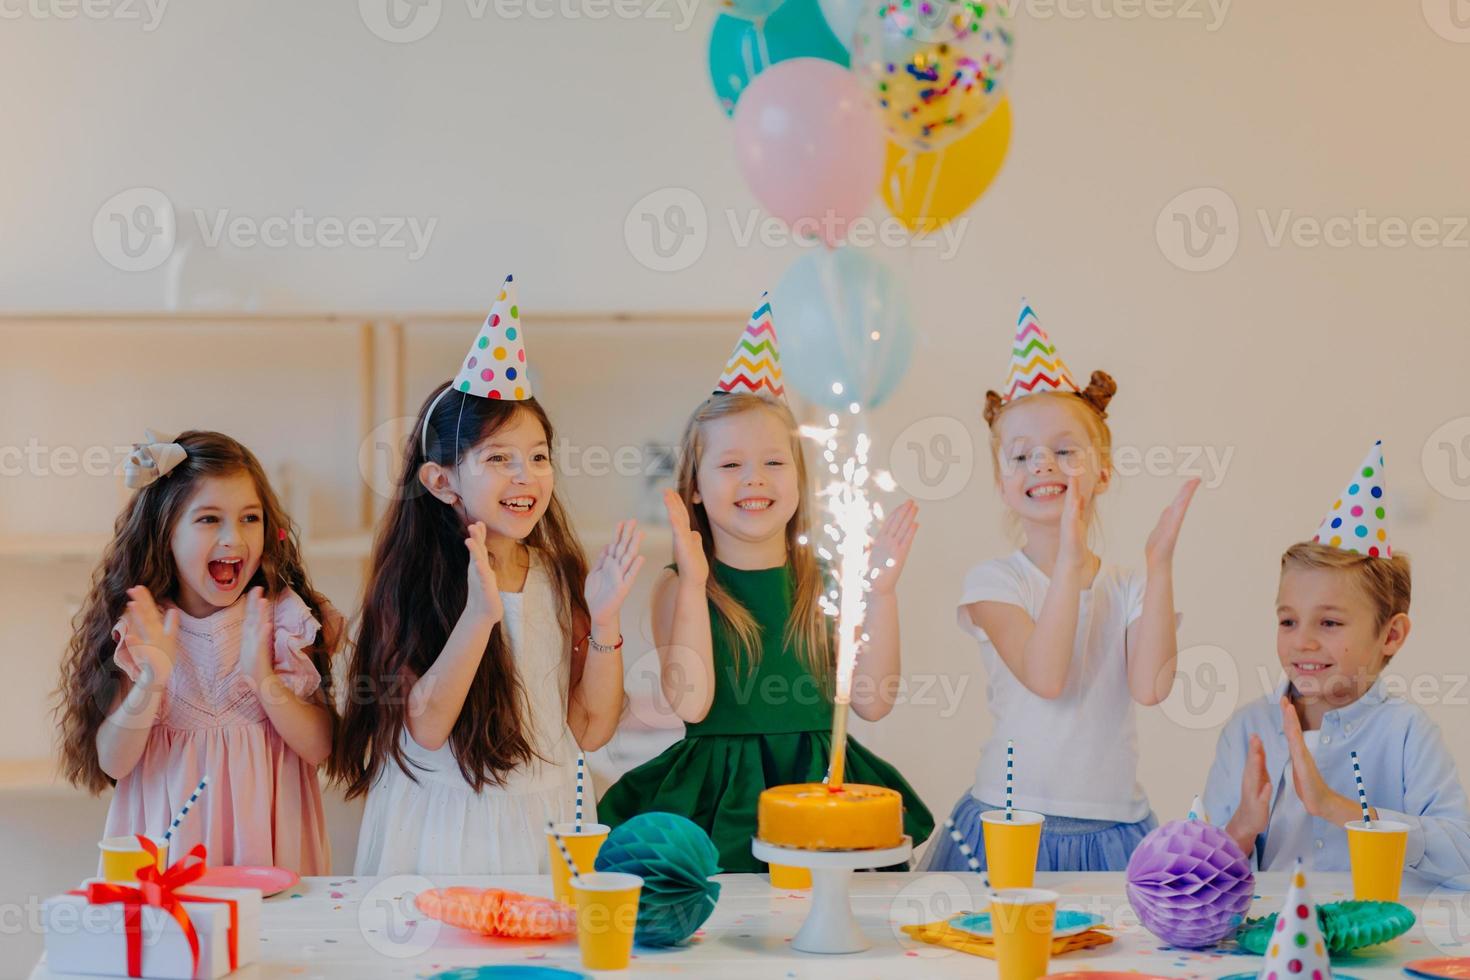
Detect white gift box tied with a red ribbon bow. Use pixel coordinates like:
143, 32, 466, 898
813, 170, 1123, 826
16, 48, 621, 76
43, 837, 260, 980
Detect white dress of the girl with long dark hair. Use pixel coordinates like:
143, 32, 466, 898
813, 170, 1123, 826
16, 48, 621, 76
353, 552, 597, 876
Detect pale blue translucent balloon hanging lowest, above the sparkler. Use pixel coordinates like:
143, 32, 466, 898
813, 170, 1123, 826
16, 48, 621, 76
770, 247, 914, 411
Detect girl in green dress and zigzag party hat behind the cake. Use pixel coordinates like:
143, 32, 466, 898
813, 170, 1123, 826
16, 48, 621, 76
598, 307, 933, 871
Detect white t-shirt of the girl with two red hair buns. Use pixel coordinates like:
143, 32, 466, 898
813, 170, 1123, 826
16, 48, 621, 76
958, 551, 1148, 823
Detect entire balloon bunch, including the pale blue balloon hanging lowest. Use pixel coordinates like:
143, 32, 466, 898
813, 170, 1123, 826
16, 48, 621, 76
709, 0, 1014, 410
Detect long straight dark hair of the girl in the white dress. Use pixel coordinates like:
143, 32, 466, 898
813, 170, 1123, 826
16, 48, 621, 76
331, 385, 589, 799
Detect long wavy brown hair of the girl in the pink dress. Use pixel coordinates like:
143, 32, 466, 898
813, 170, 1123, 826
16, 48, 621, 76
54, 430, 341, 793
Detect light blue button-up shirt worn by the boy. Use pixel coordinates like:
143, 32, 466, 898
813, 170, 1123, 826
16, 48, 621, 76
1204, 680, 1470, 889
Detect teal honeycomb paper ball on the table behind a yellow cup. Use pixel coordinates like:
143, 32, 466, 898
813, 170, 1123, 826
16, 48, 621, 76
595, 811, 720, 946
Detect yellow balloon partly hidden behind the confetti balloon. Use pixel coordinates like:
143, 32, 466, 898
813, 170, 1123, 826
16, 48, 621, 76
882, 97, 1011, 234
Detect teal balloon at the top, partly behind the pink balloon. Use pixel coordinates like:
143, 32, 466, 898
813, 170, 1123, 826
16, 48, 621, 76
710, 0, 848, 116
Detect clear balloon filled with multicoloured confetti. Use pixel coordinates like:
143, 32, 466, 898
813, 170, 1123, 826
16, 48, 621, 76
853, 0, 1014, 153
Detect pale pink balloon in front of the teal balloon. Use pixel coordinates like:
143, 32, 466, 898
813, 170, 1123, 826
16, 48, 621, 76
735, 57, 885, 248
